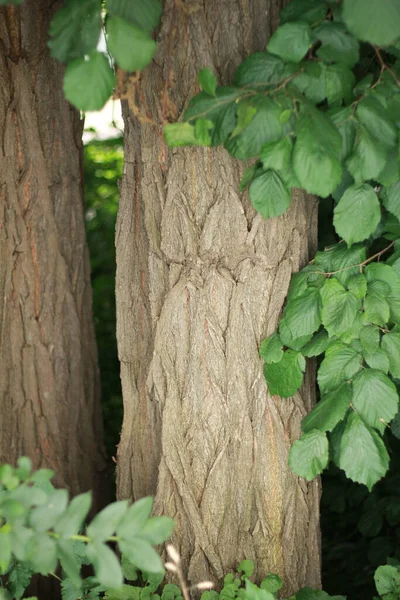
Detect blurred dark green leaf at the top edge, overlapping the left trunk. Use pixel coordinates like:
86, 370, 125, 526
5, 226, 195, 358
48, 0, 101, 62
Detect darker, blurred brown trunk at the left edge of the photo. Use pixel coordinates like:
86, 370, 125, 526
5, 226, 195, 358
0, 0, 105, 502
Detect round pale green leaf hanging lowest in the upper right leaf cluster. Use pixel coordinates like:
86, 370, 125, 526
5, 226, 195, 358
333, 183, 381, 246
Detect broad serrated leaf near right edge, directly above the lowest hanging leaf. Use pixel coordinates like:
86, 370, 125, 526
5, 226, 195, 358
352, 369, 399, 432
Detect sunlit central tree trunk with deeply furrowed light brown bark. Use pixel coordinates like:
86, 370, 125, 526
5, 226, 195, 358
117, 0, 320, 595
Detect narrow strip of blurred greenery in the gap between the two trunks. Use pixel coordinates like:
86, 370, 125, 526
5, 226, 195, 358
84, 138, 123, 456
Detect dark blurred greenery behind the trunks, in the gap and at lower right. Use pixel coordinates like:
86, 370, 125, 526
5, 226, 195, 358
85, 138, 400, 600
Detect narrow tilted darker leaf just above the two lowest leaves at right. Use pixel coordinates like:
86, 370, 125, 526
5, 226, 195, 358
301, 383, 352, 433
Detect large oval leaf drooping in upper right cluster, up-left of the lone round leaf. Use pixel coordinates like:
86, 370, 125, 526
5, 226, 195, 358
293, 109, 342, 198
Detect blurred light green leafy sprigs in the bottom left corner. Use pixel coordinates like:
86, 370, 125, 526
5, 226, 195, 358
0, 457, 173, 600
